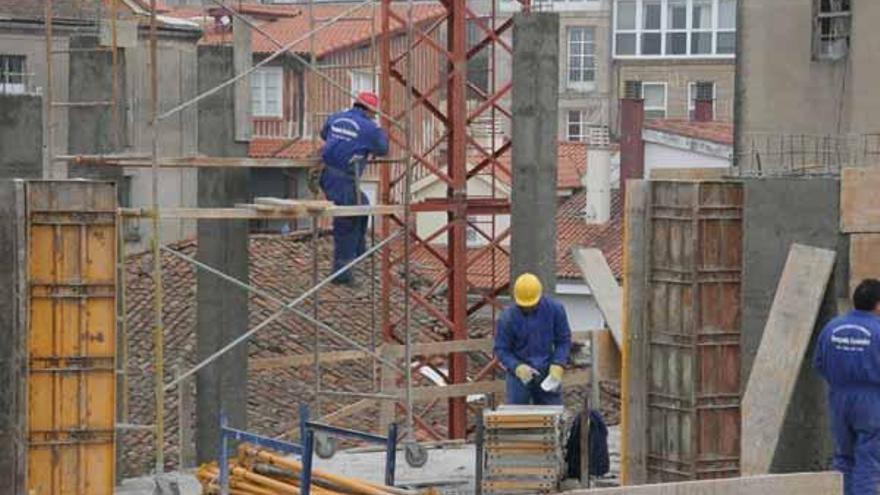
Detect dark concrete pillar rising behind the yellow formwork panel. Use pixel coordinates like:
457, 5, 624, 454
67, 35, 125, 186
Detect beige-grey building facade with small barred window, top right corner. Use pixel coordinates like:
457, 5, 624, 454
736, 0, 880, 173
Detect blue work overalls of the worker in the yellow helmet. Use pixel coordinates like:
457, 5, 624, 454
495, 296, 571, 405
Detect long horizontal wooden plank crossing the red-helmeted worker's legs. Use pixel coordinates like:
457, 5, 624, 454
119, 205, 403, 220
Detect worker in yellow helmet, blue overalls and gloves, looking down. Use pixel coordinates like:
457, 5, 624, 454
495, 273, 571, 405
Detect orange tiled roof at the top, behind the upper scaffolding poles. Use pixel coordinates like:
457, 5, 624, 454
203, 2, 445, 57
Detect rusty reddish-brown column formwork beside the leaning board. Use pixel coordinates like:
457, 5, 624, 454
645, 181, 743, 482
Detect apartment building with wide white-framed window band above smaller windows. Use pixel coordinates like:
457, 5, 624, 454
611, 0, 736, 128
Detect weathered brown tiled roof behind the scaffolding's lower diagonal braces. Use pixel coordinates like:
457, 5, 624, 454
120, 234, 492, 475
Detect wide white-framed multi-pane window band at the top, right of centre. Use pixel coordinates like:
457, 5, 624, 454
614, 0, 736, 57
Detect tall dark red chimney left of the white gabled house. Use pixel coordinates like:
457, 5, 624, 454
620, 81, 645, 194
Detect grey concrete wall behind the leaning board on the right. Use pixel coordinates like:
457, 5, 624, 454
742, 179, 849, 472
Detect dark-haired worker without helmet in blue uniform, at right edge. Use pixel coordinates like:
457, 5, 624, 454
813, 279, 880, 495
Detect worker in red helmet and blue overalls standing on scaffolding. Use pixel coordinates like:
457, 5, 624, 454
320, 91, 388, 284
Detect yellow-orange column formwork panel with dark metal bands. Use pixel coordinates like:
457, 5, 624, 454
27, 181, 117, 495
